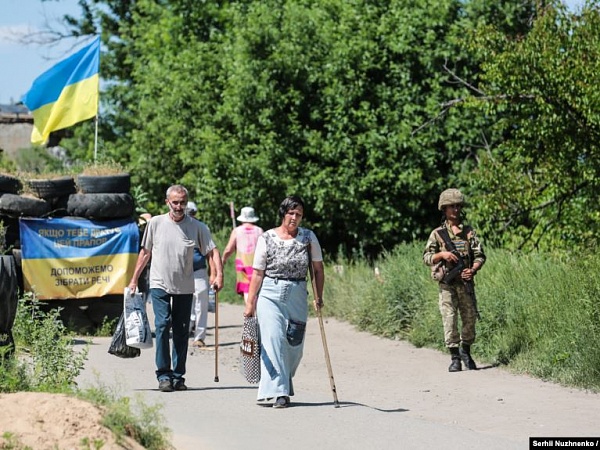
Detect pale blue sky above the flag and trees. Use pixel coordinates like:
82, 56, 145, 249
0, 0, 583, 104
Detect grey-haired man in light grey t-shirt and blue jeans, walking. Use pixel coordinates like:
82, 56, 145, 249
129, 185, 223, 392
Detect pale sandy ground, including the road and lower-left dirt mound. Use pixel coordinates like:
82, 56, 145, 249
0, 305, 600, 450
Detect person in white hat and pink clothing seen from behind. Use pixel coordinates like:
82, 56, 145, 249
223, 206, 263, 302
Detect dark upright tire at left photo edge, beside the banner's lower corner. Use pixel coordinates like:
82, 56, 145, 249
0, 255, 19, 352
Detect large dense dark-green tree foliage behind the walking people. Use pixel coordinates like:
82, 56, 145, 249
59, 0, 534, 254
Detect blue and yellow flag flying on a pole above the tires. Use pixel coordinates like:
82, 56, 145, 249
22, 37, 100, 144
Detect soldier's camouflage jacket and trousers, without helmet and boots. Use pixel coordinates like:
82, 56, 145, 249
423, 223, 485, 348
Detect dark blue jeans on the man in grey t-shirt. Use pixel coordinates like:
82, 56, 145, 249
150, 288, 193, 381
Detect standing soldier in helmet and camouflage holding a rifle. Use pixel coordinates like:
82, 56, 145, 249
423, 189, 485, 372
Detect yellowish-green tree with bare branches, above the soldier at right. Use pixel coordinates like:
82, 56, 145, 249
454, 3, 600, 250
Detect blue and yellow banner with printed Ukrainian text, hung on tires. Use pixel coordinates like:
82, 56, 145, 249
19, 218, 140, 300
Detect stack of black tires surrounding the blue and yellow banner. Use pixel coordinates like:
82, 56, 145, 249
0, 173, 135, 334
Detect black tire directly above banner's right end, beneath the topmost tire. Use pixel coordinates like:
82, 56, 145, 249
67, 194, 134, 219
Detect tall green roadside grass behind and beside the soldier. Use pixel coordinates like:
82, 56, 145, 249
325, 243, 600, 392
